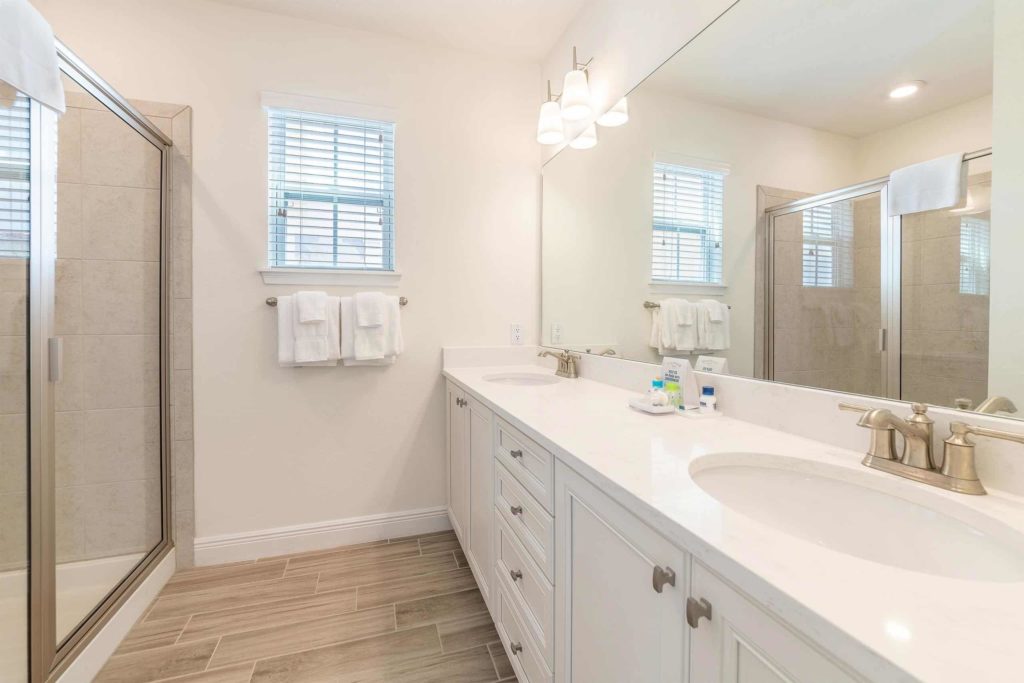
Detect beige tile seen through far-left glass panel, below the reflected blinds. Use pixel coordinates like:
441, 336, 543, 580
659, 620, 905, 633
0, 258, 29, 571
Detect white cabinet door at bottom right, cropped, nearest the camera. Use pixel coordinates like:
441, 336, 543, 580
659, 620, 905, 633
690, 562, 857, 683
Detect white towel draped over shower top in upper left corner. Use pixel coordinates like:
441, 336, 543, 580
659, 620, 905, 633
0, 0, 65, 114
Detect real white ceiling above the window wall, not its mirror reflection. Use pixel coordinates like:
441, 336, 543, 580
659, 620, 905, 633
207, 0, 585, 62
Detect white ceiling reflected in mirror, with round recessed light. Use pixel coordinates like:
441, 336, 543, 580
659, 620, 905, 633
643, 0, 993, 137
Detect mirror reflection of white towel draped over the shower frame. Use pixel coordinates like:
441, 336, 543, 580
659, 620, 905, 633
889, 154, 967, 216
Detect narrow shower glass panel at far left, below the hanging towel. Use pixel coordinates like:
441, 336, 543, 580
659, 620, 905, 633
0, 95, 32, 683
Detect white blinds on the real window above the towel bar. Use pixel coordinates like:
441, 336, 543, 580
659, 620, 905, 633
267, 109, 394, 271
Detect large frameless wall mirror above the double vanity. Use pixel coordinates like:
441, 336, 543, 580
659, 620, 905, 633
542, 0, 1024, 416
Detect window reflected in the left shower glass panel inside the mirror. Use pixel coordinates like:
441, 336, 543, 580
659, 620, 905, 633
803, 200, 853, 287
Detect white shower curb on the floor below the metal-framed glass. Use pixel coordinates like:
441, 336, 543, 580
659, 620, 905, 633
57, 548, 175, 683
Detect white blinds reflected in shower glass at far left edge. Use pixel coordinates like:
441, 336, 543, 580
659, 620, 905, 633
0, 94, 32, 258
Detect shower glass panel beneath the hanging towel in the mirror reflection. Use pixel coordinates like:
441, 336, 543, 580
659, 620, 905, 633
901, 163, 992, 409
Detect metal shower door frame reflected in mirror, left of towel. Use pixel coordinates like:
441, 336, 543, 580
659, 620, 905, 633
763, 178, 901, 398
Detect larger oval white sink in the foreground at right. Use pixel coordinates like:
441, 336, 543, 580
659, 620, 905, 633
690, 454, 1024, 582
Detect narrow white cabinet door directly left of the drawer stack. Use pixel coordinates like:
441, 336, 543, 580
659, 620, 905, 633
463, 398, 495, 605
